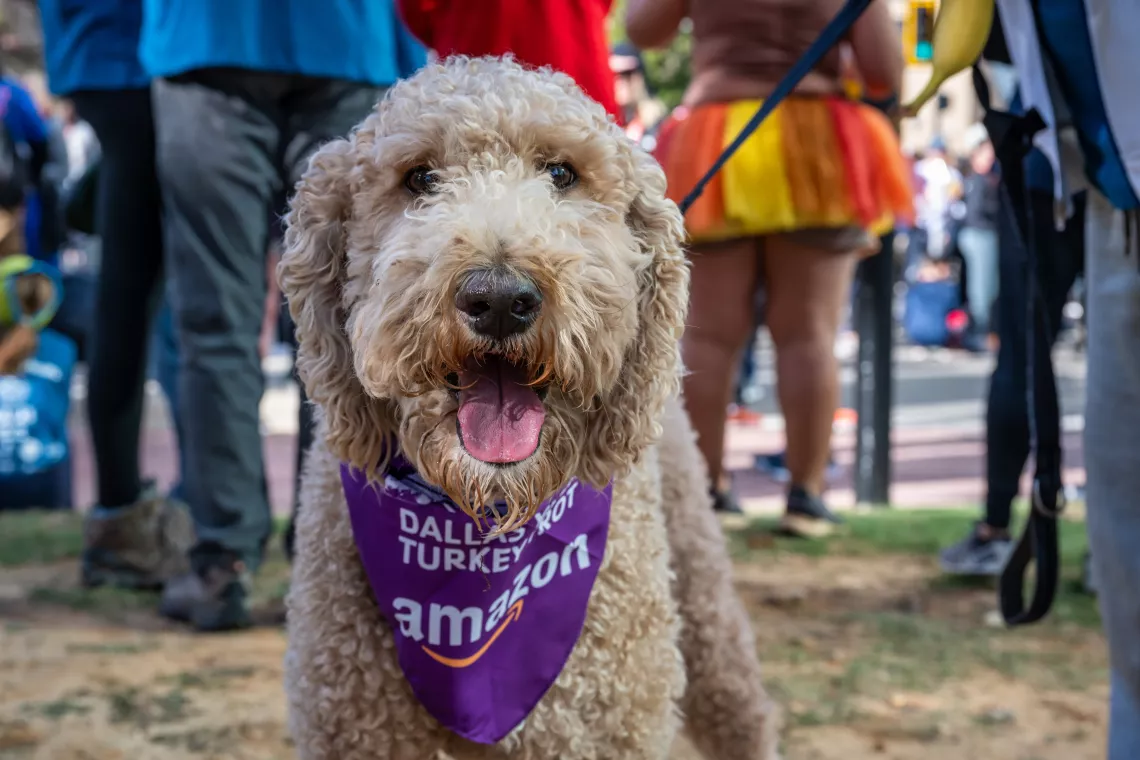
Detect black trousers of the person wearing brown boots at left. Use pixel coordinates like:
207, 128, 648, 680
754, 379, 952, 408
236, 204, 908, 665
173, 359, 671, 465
73, 89, 163, 507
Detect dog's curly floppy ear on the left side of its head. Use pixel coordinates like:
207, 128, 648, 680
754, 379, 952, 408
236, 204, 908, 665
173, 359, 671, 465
277, 136, 393, 468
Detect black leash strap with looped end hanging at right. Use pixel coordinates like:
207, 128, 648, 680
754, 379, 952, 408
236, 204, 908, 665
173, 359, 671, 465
974, 66, 1065, 626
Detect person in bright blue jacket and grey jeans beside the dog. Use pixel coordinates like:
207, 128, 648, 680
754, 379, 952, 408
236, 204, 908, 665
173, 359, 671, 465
139, 0, 426, 630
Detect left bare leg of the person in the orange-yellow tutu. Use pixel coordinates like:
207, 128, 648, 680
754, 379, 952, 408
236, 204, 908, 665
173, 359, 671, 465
682, 238, 759, 496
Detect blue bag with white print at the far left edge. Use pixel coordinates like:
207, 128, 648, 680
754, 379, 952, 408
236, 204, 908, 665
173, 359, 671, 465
0, 329, 76, 509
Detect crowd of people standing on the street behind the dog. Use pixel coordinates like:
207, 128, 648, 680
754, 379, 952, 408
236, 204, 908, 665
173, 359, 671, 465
0, 0, 1140, 757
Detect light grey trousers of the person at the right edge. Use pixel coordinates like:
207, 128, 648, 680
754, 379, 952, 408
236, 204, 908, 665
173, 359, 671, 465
1084, 190, 1140, 760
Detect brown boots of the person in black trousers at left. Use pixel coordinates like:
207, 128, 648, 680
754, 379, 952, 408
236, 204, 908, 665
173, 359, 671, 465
81, 483, 194, 590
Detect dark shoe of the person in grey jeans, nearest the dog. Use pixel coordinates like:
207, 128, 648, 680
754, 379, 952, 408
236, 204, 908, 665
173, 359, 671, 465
158, 561, 250, 632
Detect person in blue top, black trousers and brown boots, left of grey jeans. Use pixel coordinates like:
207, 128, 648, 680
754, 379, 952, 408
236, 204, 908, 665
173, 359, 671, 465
40, 0, 193, 588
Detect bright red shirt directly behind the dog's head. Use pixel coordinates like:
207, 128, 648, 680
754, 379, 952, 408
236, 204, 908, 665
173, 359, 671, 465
399, 0, 620, 121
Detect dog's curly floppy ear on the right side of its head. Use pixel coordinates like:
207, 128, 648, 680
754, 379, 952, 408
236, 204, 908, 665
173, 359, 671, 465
584, 149, 689, 485
